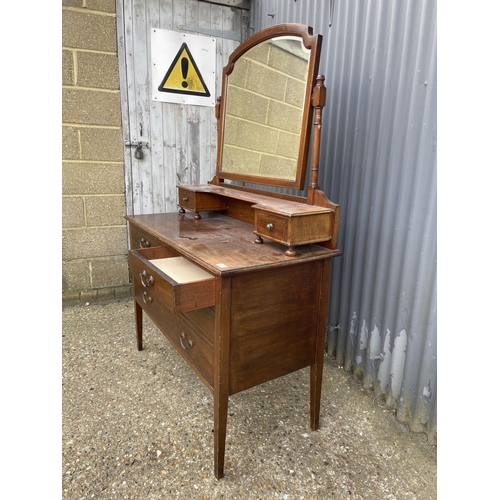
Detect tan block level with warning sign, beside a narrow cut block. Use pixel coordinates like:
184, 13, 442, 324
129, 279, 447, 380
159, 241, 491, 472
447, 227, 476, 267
76, 52, 120, 90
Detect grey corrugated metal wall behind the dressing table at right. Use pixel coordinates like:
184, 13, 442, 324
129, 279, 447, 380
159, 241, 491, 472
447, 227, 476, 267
249, 0, 437, 442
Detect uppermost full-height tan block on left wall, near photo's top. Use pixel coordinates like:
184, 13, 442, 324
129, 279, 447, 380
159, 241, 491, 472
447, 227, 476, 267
62, 9, 116, 52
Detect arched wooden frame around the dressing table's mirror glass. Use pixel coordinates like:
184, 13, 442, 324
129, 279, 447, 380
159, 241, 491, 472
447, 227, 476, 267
212, 23, 322, 190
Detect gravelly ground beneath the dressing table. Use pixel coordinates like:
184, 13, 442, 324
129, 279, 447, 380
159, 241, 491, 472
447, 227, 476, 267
62, 299, 437, 500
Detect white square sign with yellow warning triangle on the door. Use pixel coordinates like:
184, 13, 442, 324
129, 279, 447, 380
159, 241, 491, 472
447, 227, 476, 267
151, 28, 215, 106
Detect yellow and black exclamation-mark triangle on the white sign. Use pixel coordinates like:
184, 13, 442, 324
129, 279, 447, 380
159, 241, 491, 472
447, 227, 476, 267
158, 42, 210, 97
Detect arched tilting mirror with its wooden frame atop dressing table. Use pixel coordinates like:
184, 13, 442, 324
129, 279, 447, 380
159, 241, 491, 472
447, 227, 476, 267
217, 25, 319, 189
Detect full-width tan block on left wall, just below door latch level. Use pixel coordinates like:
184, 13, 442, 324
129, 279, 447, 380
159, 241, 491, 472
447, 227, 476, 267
62, 162, 125, 195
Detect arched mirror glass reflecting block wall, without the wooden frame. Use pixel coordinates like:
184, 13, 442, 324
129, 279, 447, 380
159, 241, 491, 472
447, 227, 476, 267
221, 36, 310, 181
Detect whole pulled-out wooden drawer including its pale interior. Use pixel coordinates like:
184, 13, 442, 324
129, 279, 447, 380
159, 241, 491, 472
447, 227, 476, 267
129, 247, 215, 313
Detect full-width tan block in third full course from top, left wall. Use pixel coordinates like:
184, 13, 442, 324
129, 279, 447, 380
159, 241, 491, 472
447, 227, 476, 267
62, 88, 121, 127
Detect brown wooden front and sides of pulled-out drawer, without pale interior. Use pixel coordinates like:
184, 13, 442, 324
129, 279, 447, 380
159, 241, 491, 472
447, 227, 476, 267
129, 247, 215, 313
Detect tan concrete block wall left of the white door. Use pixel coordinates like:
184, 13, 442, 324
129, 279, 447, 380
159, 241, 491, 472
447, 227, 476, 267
62, 0, 130, 301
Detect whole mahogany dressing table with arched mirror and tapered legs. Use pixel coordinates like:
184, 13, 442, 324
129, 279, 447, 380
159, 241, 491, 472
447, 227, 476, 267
126, 24, 341, 479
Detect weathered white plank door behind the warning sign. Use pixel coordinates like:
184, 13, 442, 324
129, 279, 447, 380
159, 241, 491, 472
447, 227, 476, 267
117, 0, 242, 215
